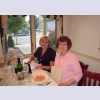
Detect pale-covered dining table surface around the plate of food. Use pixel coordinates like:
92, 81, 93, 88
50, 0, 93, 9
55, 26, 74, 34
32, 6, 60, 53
0, 68, 58, 86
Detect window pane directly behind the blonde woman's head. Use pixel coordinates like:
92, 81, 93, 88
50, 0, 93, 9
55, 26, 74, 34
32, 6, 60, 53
35, 15, 56, 50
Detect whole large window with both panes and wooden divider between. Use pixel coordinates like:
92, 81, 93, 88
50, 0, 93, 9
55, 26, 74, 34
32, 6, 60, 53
2, 15, 61, 55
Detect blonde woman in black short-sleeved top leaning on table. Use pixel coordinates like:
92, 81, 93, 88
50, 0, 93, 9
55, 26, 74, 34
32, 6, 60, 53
28, 36, 56, 72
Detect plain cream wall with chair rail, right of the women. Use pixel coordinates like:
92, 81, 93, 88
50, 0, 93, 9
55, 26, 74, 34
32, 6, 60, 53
63, 15, 100, 72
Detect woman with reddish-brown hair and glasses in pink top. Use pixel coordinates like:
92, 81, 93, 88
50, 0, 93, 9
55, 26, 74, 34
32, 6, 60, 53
55, 36, 83, 86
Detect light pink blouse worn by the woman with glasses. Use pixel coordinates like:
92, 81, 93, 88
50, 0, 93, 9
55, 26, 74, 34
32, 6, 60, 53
54, 51, 83, 85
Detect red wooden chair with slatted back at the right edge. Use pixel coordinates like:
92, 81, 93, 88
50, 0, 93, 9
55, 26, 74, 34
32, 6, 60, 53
83, 70, 100, 86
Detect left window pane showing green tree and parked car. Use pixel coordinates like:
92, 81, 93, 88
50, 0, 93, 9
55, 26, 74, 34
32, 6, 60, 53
6, 15, 31, 54
